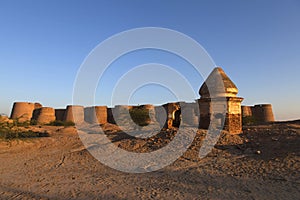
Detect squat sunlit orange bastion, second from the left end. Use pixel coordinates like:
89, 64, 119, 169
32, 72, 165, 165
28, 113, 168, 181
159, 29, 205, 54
32, 107, 56, 124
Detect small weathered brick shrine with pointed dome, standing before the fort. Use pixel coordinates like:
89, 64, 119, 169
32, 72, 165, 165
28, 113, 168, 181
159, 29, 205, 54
198, 67, 243, 134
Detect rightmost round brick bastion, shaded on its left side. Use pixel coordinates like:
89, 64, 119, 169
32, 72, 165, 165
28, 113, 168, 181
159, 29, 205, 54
251, 104, 275, 123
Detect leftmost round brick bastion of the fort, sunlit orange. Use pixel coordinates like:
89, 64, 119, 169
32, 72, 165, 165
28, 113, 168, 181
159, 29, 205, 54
10, 102, 41, 122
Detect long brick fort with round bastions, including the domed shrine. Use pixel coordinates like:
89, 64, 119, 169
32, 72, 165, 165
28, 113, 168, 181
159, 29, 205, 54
10, 67, 274, 134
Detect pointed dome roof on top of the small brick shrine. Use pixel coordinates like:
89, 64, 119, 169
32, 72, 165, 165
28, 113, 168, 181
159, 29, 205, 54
199, 67, 238, 97
